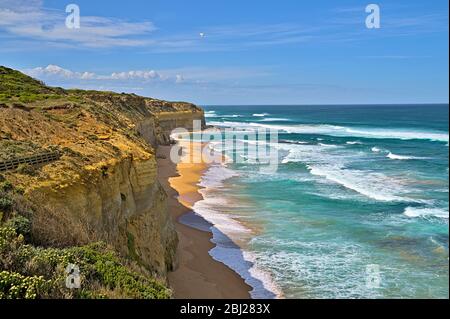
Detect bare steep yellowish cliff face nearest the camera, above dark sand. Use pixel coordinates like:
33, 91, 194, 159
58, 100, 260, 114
28, 156, 178, 278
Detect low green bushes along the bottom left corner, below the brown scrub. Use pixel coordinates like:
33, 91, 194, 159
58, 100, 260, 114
0, 227, 171, 299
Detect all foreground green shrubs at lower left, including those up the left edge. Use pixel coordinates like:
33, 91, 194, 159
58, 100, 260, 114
0, 178, 171, 299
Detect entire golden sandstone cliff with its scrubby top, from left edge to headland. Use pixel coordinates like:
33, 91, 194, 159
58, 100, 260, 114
0, 67, 204, 279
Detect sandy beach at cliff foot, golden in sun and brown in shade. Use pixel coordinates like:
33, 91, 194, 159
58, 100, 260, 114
158, 141, 251, 299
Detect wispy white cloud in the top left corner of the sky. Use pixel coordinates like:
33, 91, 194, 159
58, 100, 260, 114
0, 0, 156, 48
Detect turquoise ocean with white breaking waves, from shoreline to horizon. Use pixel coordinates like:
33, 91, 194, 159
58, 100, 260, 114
189, 105, 449, 298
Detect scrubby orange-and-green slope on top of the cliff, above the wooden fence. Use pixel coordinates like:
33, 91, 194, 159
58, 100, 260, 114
0, 66, 202, 165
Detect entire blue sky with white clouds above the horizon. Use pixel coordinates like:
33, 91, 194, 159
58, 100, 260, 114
0, 0, 449, 105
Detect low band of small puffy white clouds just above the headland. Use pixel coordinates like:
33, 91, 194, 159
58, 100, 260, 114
22, 64, 273, 95
